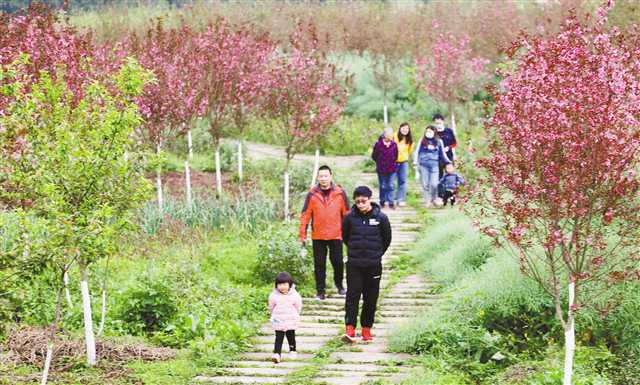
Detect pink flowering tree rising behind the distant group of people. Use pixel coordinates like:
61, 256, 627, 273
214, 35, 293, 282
416, 22, 489, 128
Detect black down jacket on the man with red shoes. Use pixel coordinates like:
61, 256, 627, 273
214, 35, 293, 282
342, 203, 391, 267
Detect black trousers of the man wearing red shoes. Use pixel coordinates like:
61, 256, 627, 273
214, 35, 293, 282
344, 262, 382, 327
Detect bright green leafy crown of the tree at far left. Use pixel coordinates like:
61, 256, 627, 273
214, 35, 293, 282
0, 56, 151, 280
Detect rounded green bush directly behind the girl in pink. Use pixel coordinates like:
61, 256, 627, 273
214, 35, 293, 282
255, 226, 313, 284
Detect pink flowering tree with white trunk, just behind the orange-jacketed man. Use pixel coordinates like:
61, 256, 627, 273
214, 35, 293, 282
264, 22, 347, 218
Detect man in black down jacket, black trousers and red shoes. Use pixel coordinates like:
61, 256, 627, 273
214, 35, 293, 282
342, 186, 391, 343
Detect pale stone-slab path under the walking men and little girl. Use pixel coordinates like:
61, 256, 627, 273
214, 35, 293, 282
194, 174, 436, 385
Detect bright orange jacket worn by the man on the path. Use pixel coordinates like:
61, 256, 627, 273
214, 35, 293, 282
300, 183, 349, 242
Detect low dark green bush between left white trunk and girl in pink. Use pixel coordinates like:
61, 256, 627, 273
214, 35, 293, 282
118, 276, 178, 335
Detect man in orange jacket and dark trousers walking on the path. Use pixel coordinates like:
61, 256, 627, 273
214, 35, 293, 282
300, 165, 349, 300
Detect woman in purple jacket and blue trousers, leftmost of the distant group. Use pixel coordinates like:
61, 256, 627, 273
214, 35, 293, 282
371, 127, 398, 209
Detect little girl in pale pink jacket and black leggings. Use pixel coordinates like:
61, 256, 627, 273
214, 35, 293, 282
269, 272, 302, 364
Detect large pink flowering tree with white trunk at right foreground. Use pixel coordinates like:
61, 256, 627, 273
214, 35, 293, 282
475, 9, 640, 385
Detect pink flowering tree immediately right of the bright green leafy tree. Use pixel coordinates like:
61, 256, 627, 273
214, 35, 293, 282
116, 22, 205, 212
